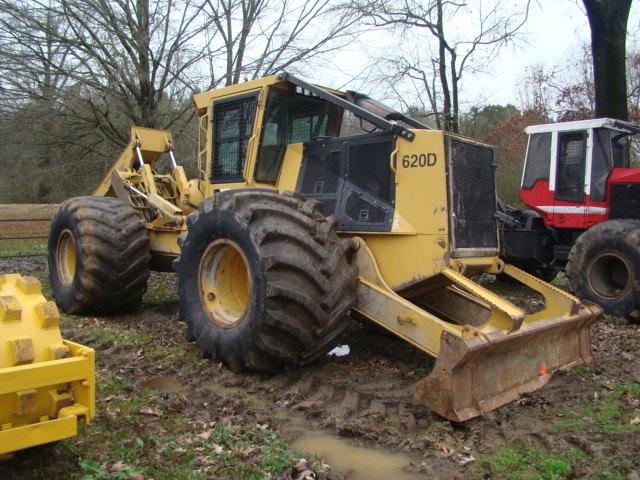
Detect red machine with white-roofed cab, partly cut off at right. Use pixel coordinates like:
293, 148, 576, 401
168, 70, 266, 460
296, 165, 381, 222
498, 118, 640, 319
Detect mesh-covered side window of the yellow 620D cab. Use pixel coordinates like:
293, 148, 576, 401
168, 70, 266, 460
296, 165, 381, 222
211, 96, 257, 182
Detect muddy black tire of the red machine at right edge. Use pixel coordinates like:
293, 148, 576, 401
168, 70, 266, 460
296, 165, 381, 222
566, 220, 640, 320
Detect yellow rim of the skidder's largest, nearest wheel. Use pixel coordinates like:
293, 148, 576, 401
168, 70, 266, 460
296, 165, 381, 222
198, 239, 251, 328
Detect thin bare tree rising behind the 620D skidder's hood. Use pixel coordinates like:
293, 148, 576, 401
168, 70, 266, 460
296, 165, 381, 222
356, 0, 530, 131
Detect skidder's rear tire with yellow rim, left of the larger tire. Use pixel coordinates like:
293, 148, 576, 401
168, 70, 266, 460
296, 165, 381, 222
49, 197, 151, 315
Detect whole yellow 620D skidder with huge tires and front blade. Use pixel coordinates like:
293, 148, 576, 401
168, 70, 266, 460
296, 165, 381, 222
52, 74, 599, 421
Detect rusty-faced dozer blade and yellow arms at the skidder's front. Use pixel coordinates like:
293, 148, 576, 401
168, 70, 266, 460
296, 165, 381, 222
356, 245, 602, 422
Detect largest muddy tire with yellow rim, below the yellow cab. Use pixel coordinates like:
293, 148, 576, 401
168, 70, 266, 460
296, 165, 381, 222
175, 188, 358, 373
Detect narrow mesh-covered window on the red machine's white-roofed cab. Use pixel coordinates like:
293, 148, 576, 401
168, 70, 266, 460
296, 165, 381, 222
556, 132, 586, 202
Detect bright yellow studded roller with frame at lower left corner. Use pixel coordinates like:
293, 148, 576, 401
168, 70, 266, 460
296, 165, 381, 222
0, 274, 95, 458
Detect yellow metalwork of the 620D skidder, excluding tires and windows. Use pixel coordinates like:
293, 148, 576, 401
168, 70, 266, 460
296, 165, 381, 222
95, 74, 600, 421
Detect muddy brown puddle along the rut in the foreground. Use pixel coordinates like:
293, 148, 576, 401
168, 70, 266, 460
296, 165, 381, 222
140, 377, 421, 480
